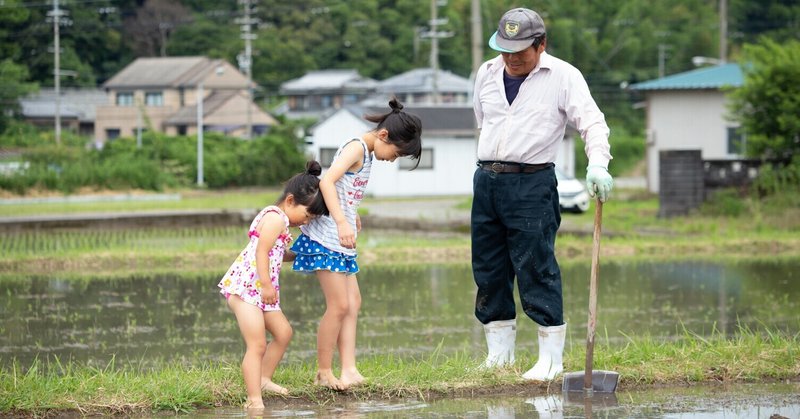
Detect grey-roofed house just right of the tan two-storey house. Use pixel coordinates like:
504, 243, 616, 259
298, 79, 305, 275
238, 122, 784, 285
280, 69, 377, 119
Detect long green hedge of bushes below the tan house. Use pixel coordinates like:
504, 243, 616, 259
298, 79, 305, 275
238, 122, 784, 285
0, 126, 305, 194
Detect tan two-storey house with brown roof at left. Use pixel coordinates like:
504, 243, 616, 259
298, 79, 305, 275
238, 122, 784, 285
94, 57, 277, 142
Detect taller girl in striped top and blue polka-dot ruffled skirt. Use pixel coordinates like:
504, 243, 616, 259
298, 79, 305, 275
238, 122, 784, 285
292, 99, 422, 390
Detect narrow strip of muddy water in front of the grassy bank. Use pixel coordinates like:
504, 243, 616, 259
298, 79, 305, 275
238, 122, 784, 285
192, 384, 800, 419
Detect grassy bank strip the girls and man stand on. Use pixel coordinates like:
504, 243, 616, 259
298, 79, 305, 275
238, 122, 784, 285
0, 330, 800, 415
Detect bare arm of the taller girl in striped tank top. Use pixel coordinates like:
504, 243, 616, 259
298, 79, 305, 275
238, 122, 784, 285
319, 141, 364, 249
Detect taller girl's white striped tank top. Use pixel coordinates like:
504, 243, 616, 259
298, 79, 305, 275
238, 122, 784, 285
300, 138, 372, 256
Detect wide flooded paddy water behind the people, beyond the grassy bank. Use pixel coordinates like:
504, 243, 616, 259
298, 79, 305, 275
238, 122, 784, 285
0, 261, 800, 366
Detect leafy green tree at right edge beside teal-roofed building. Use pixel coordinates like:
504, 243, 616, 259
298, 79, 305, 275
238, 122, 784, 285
729, 38, 800, 158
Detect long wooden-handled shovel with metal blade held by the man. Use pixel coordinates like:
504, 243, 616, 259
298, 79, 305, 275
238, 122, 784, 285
561, 198, 619, 397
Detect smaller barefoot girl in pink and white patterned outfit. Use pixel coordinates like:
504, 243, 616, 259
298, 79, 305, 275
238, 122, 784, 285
219, 161, 328, 408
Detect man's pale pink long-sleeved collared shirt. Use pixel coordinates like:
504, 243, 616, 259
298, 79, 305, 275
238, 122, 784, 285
473, 52, 611, 167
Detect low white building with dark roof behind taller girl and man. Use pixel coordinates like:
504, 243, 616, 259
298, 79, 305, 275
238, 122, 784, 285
306, 101, 575, 197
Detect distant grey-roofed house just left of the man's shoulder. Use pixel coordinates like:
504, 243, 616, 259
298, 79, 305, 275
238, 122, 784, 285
377, 68, 472, 105
